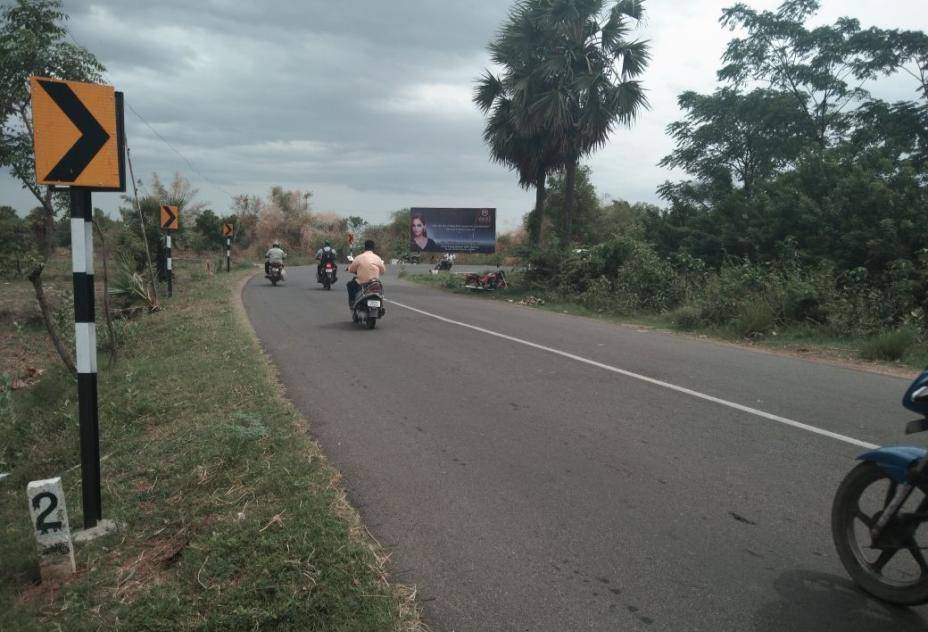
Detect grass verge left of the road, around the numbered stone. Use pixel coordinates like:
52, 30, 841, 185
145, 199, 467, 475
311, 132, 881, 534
0, 271, 421, 631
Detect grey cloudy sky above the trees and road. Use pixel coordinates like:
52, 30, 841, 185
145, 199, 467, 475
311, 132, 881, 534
0, 0, 928, 230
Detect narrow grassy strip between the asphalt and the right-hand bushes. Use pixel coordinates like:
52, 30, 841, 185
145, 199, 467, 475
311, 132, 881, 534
401, 273, 928, 375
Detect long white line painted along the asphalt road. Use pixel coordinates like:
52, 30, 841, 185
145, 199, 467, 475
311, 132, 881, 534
388, 300, 879, 450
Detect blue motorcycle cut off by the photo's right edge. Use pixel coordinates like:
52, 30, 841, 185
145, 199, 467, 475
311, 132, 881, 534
831, 369, 928, 606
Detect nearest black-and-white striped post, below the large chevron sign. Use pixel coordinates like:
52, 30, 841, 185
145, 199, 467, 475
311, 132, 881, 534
70, 187, 103, 529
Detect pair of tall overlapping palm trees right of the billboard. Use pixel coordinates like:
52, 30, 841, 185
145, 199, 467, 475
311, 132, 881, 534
474, 0, 650, 247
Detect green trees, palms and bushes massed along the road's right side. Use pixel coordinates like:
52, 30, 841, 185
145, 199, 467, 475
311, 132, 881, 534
428, 0, 928, 367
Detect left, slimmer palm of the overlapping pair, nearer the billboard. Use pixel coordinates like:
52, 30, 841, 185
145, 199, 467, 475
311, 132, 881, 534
474, 2, 563, 246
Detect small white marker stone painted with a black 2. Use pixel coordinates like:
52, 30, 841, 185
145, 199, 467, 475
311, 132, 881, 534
26, 477, 76, 581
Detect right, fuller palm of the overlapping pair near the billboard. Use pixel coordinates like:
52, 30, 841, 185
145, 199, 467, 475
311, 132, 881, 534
520, 0, 650, 246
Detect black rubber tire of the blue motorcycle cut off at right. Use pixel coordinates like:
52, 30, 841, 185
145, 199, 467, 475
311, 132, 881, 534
831, 462, 928, 606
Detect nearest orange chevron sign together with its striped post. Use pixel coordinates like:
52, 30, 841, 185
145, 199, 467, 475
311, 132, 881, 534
30, 77, 126, 529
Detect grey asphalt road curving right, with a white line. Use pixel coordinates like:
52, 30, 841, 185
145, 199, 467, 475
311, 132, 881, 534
244, 268, 928, 632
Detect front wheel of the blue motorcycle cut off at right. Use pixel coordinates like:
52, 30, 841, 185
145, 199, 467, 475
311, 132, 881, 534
831, 462, 928, 606
